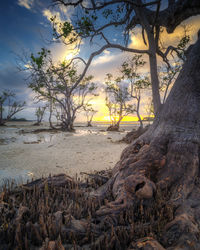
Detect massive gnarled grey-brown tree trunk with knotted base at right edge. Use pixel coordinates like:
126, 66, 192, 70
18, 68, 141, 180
93, 33, 200, 249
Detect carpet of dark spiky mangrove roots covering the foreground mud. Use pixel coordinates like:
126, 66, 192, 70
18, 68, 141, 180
0, 171, 175, 250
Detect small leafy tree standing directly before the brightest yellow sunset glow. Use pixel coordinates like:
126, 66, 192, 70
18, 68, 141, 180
105, 74, 135, 131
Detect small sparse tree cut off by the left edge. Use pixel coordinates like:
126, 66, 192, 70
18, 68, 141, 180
0, 90, 26, 126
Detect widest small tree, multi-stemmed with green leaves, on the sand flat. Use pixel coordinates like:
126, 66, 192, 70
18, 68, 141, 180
29, 49, 96, 131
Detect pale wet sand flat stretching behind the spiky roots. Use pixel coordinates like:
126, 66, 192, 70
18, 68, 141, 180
0, 122, 132, 183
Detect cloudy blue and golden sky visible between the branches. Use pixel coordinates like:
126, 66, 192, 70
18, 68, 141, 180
0, 0, 200, 120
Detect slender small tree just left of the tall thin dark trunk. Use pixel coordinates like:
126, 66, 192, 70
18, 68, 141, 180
120, 55, 151, 128
